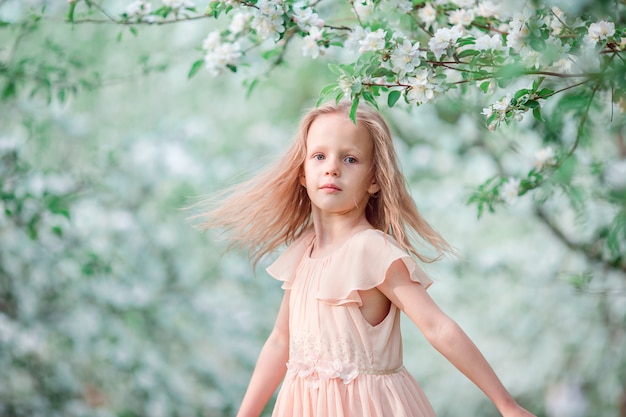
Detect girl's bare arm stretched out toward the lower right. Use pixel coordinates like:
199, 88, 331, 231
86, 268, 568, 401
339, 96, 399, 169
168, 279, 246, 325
378, 260, 533, 417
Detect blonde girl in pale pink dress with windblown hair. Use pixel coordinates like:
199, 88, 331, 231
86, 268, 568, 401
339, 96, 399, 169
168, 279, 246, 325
203, 103, 532, 417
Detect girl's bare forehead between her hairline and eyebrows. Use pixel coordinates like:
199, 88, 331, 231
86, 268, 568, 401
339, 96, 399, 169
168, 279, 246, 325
306, 112, 374, 152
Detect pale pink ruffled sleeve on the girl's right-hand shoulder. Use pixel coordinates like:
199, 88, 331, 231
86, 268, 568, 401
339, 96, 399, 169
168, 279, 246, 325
317, 229, 432, 306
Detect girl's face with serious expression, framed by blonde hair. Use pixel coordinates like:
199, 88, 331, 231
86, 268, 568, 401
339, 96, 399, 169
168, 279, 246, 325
300, 113, 380, 219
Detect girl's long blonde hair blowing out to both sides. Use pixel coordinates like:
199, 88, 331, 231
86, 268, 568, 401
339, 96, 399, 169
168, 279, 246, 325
198, 102, 452, 264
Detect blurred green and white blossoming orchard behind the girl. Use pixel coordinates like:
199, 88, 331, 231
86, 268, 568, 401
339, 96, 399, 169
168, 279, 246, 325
0, 0, 626, 417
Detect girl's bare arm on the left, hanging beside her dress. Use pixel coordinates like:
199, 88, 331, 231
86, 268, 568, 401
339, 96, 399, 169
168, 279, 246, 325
237, 290, 290, 417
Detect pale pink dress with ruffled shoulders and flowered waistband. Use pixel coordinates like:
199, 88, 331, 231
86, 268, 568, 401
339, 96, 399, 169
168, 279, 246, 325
267, 229, 435, 417
